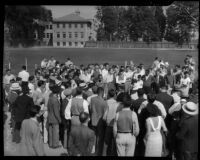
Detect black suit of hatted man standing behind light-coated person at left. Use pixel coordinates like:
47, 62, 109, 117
13, 94, 34, 143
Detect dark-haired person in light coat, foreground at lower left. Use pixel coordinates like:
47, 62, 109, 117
19, 105, 45, 156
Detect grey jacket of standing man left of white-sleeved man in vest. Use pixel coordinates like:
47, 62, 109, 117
47, 93, 61, 124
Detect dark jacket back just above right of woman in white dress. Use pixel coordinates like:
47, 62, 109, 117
156, 92, 174, 112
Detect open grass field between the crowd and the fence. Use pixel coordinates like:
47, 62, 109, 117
4, 48, 198, 74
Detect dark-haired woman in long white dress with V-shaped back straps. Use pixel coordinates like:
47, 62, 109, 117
144, 104, 167, 157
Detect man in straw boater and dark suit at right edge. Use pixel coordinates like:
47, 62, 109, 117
176, 102, 198, 160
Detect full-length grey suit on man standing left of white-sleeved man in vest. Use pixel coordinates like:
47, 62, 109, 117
47, 93, 61, 147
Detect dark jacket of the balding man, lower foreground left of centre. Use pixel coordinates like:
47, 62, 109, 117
69, 125, 95, 156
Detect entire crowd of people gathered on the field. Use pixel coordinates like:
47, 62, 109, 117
3, 55, 199, 160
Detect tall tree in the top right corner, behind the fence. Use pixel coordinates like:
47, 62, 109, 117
165, 1, 199, 45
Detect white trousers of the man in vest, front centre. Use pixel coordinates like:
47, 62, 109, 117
116, 133, 136, 157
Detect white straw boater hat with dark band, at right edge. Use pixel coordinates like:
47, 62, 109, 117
182, 102, 199, 115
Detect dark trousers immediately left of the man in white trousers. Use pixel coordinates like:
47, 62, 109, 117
103, 126, 117, 156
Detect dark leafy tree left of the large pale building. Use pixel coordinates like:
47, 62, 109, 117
5, 5, 52, 46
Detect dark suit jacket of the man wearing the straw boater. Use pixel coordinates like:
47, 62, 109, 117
176, 115, 198, 153
